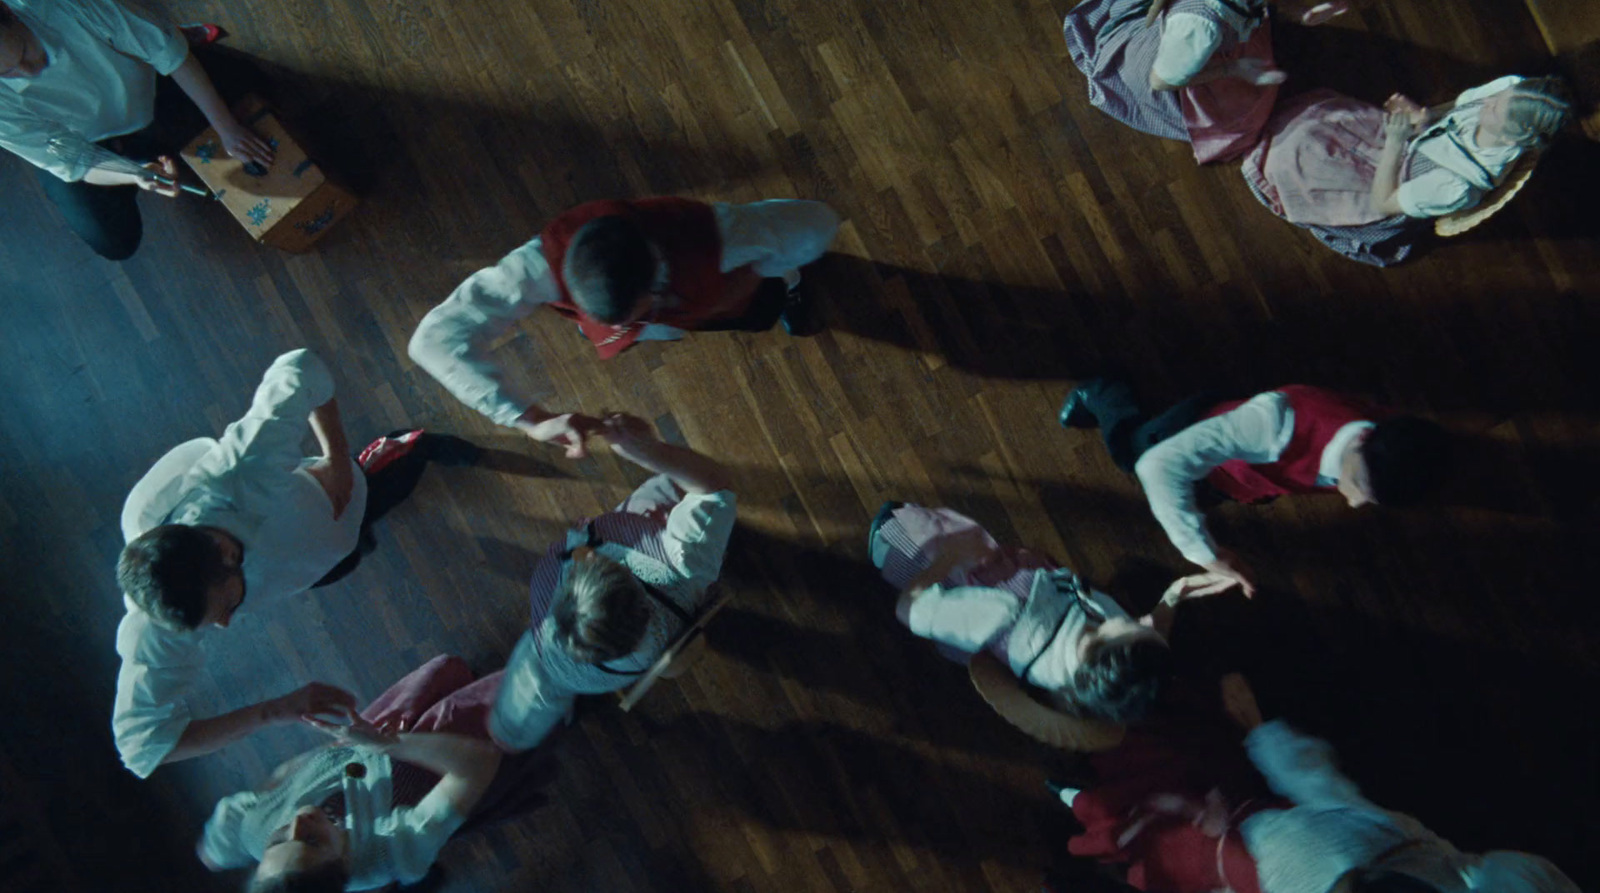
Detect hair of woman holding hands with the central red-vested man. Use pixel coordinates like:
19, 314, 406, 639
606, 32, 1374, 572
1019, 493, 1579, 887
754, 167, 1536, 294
550, 552, 650, 664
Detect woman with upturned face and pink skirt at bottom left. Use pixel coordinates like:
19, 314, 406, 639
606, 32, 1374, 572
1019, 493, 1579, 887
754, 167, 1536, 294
195, 655, 549, 893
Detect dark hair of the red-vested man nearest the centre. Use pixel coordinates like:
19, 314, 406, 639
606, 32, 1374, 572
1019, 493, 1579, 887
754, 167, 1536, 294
562, 214, 656, 323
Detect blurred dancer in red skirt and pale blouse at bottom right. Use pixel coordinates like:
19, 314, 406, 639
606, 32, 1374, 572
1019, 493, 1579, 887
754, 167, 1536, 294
1059, 674, 1578, 893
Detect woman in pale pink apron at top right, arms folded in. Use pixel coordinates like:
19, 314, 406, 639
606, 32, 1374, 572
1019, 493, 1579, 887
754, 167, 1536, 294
1242, 75, 1571, 267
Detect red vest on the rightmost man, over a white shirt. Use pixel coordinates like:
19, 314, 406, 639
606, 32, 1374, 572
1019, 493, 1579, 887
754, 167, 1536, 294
1206, 384, 1379, 503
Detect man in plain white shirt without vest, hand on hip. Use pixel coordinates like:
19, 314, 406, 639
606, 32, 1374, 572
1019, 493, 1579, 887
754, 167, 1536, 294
112, 350, 459, 778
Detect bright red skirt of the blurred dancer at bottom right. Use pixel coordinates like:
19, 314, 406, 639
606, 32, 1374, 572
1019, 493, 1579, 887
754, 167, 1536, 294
1067, 720, 1282, 893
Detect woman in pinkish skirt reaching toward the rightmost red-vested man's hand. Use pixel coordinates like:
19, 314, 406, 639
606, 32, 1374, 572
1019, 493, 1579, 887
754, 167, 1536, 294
867, 503, 1230, 722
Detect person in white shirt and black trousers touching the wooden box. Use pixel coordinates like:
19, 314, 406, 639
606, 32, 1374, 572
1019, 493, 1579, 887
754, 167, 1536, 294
0, 0, 272, 261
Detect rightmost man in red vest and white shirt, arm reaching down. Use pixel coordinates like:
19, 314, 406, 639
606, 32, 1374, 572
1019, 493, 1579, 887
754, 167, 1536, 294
1059, 379, 1450, 595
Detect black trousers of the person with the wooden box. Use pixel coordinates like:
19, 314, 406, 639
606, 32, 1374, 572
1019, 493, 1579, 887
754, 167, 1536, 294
37, 46, 262, 261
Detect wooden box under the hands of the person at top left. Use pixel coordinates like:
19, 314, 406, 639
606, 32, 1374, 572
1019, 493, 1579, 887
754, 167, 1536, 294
182, 98, 357, 253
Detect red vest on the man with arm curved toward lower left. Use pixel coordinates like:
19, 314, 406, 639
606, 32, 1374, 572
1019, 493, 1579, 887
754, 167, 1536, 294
539, 198, 732, 360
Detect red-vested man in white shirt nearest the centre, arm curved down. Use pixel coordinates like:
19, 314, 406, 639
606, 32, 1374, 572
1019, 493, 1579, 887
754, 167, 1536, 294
408, 198, 840, 458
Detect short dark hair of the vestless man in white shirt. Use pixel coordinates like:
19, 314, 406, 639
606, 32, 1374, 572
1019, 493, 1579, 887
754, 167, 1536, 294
117, 523, 232, 631
